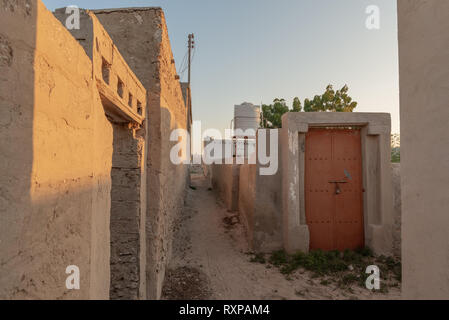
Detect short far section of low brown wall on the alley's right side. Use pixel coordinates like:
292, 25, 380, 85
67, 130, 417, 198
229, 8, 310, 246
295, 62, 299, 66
210, 164, 240, 211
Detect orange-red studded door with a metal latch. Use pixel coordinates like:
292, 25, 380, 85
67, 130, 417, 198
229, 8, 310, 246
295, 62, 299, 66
305, 128, 365, 251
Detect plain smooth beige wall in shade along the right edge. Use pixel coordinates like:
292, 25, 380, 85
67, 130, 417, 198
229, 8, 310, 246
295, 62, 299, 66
398, 0, 449, 299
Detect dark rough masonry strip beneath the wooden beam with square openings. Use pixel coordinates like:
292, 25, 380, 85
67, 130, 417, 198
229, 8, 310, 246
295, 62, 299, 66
110, 124, 145, 300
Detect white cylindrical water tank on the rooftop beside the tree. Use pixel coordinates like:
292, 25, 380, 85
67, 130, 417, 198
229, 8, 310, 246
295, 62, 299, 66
234, 102, 260, 139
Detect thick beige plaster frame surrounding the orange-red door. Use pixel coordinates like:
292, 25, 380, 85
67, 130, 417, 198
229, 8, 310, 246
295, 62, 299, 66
280, 112, 393, 255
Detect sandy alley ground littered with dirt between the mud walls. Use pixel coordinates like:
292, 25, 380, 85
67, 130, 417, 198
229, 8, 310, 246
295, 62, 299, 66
163, 170, 400, 300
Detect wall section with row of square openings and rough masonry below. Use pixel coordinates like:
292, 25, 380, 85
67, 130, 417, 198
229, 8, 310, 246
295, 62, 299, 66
54, 8, 147, 300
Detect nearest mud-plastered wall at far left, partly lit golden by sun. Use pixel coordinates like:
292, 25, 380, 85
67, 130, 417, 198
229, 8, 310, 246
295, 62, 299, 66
0, 0, 112, 299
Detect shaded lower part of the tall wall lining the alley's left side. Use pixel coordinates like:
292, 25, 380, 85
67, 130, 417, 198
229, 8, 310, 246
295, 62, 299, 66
146, 107, 188, 299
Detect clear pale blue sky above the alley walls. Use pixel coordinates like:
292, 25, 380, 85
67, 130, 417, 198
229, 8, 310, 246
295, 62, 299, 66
43, 0, 399, 132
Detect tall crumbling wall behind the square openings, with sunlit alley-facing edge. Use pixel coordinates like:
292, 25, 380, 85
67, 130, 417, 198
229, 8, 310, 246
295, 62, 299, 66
94, 8, 188, 299
